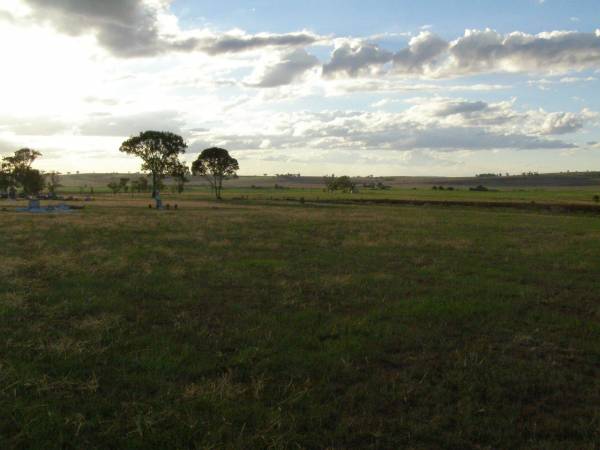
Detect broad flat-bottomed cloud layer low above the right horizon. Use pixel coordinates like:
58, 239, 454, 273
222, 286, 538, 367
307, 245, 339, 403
191, 98, 594, 152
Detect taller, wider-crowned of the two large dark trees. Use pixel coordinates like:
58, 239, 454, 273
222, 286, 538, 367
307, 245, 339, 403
119, 131, 187, 198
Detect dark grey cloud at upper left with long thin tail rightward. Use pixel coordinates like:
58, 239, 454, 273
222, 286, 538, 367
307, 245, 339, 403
23, 0, 321, 58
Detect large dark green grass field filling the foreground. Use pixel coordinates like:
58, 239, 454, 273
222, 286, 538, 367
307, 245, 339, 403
0, 195, 600, 449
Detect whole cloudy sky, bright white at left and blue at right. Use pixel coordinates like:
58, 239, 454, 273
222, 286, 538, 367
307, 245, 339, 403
0, 0, 600, 176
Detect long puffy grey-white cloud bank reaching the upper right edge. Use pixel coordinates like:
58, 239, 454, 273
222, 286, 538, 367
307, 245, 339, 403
323, 29, 600, 78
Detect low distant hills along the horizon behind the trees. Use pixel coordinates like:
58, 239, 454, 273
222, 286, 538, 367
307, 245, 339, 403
61, 172, 600, 188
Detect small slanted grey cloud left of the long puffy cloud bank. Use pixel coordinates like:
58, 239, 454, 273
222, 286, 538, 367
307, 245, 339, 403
247, 49, 319, 88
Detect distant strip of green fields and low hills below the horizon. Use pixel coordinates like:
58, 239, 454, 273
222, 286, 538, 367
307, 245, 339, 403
56, 173, 600, 204
